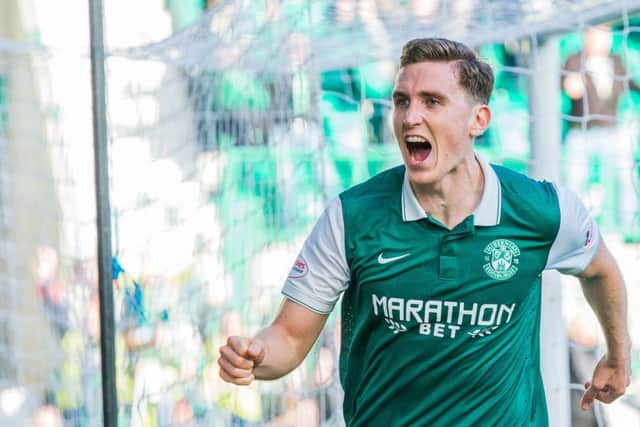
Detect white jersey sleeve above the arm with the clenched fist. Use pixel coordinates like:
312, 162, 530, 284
282, 197, 350, 314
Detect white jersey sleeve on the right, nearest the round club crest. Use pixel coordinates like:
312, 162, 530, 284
545, 186, 600, 275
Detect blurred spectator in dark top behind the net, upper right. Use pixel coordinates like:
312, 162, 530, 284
562, 26, 640, 239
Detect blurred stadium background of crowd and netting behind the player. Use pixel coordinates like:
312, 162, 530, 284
0, 0, 640, 427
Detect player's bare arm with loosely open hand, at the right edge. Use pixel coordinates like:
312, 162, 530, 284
578, 242, 630, 409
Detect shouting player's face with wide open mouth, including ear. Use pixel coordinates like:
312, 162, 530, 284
393, 61, 489, 184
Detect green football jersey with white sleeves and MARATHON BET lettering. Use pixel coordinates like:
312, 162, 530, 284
283, 155, 599, 427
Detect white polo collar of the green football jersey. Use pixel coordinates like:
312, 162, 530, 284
402, 153, 502, 227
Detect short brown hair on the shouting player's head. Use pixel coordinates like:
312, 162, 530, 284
400, 38, 494, 104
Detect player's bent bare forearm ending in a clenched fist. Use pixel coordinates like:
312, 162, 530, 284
218, 298, 328, 385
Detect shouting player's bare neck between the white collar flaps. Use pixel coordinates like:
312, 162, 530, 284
411, 153, 484, 229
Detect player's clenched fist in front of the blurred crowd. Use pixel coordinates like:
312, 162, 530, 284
218, 337, 264, 385
